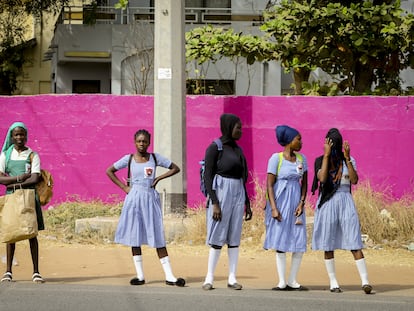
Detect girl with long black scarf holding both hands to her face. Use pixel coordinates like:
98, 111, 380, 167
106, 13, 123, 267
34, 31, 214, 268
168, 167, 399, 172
312, 128, 372, 294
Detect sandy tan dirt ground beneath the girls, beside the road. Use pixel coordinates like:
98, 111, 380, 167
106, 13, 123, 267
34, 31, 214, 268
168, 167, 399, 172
0, 236, 414, 297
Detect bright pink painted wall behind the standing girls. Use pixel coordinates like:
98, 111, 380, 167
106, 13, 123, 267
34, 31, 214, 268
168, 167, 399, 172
0, 95, 414, 206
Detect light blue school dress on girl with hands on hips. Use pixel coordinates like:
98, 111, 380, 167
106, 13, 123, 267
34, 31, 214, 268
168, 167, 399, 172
114, 153, 172, 248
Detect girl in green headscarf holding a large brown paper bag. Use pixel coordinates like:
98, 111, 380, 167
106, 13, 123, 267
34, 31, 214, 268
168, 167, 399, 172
0, 122, 44, 283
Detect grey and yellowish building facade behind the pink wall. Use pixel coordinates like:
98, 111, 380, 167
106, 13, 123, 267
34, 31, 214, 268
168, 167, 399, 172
18, 0, 414, 95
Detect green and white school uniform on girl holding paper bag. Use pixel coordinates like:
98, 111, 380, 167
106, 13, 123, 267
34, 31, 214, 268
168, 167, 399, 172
0, 147, 45, 230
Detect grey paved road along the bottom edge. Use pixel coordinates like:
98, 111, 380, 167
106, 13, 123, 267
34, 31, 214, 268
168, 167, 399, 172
0, 282, 414, 311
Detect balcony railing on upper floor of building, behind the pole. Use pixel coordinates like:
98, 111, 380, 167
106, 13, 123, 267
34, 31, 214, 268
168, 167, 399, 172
58, 6, 263, 26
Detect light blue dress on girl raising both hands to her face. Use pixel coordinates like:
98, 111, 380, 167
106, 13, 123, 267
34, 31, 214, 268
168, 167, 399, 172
312, 157, 363, 251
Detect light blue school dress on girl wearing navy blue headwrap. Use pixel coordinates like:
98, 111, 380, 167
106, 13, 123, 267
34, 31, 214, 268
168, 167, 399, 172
263, 153, 308, 252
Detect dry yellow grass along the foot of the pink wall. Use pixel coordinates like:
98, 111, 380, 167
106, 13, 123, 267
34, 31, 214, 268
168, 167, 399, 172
40, 182, 414, 249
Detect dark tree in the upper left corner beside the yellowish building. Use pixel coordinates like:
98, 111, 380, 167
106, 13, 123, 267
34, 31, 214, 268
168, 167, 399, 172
0, 0, 68, 95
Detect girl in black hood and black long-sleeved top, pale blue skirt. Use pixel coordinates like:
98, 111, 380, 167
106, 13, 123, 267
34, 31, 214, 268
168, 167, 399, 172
203, 114, 252, 290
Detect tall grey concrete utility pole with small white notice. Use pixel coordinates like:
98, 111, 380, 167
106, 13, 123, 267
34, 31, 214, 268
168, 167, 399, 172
154, 0, 187, 213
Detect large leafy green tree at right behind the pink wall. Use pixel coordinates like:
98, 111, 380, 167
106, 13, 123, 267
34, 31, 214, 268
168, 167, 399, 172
262, 0, 414, 94
